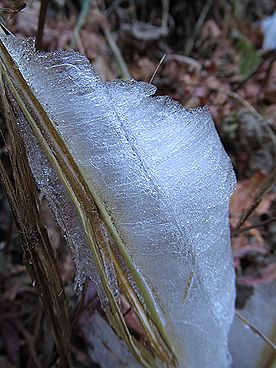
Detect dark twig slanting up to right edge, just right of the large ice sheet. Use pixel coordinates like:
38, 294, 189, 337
233, 167, 276, 236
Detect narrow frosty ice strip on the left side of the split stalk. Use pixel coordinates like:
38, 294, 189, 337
16, 106, 108, 304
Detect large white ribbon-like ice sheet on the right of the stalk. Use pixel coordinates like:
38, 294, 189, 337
1, 37, 235, 368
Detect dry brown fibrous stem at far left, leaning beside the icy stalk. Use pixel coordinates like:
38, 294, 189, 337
0, 75, 71, 368
